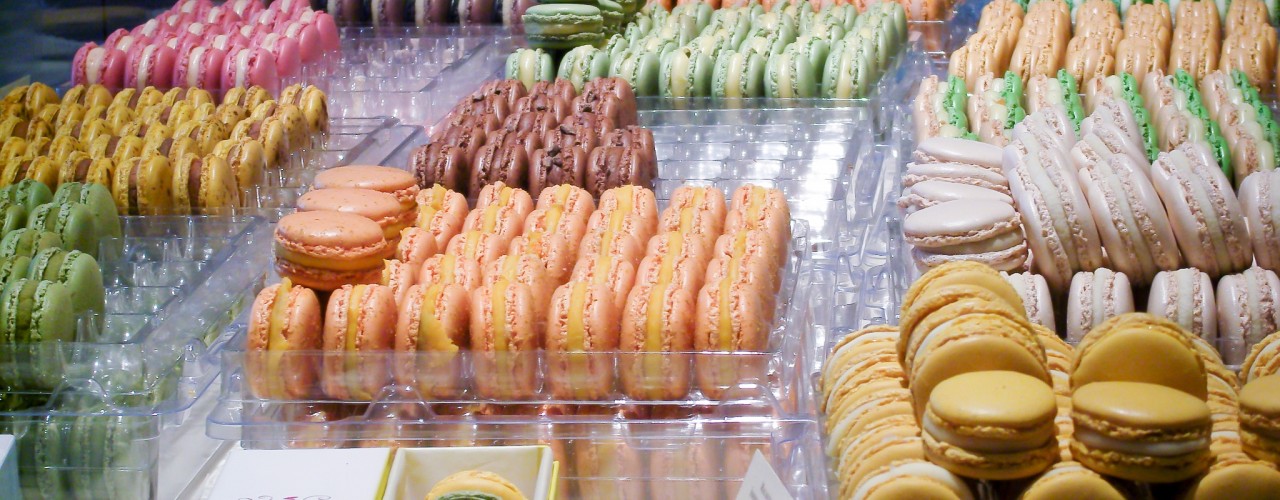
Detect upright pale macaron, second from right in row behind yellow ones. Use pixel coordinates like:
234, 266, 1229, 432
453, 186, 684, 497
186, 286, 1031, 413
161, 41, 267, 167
1146, 269, 1219, 345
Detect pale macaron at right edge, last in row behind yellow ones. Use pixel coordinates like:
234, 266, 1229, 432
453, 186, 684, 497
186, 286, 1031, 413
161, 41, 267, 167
1216, 267, 1280, 364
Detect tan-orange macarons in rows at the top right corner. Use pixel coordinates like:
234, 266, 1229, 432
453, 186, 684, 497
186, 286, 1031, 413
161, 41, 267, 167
950, 0, 1276, 87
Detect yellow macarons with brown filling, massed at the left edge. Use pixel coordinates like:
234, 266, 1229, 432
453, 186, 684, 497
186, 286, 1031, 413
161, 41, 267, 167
0, 83, 329, 215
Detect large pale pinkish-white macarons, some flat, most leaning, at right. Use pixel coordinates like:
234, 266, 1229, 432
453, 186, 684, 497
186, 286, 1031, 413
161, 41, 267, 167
900, 92, 1280, 293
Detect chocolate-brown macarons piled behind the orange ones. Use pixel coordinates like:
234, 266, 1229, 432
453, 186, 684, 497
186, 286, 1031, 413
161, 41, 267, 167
408, 77, 658, 198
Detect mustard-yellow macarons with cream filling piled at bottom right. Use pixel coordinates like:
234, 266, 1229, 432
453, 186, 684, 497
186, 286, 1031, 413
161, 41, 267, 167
822, 262, 1276, 497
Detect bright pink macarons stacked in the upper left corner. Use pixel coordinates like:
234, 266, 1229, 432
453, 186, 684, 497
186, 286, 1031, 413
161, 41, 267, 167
72, 0, 339, 92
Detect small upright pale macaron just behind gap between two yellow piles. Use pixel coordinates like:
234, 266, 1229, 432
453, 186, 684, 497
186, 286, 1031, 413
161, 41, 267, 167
1066, 267, 1134, 343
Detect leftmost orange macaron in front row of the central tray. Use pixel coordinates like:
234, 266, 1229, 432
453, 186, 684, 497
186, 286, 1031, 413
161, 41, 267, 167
244, 277, 323, 399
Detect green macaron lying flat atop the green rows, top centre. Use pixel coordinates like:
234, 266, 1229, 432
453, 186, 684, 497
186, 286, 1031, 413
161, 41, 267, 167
521, 4, 604, 50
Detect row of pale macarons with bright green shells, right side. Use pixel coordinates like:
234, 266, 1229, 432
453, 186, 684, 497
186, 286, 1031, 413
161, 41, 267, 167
913, 69, 1280, 185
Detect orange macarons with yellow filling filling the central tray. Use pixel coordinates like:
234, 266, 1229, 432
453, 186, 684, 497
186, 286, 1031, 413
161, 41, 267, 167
247, 180, 790, 400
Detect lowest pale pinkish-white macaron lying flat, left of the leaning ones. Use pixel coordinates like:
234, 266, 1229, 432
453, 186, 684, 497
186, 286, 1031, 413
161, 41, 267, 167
902, 199, 1027, 272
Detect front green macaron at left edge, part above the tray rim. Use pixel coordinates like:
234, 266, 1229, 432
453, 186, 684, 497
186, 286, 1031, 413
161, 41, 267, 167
0, 279, 76, 343
